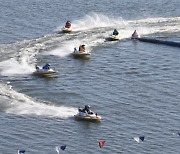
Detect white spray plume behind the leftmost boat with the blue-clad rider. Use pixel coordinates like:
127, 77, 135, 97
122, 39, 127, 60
0, 42, 44, 76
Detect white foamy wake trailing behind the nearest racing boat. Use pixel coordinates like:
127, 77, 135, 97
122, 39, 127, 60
0, 83, 77, 118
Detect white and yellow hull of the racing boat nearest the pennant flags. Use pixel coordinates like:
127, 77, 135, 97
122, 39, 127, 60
74, 108, 101, 121
